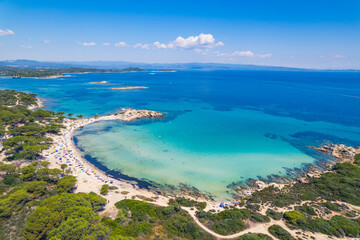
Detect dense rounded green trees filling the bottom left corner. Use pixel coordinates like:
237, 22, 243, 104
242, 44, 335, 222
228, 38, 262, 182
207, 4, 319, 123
0, 161, 105, 239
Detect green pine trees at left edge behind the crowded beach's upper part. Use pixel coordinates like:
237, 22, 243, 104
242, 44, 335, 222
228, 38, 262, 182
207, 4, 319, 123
0, 90, 63, 160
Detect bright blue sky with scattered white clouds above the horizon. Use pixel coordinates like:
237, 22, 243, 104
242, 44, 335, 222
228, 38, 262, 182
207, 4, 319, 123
0, 0, 360, 69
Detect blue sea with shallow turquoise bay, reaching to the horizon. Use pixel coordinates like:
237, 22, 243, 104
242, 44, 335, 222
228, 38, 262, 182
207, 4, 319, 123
0, 71, 360, 198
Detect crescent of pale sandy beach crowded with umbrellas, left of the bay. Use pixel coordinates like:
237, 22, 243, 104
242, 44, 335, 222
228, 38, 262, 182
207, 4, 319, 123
42, 109, 224, 210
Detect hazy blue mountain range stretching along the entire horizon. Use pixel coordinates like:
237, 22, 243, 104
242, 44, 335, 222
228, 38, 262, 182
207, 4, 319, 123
0, 59, 360, 72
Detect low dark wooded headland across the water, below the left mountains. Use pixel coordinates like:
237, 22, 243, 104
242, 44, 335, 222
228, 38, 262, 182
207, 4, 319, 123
0, 66, 145, 77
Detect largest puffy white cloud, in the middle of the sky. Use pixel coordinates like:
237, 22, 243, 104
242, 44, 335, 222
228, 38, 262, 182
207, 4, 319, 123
153, 33, 224, 50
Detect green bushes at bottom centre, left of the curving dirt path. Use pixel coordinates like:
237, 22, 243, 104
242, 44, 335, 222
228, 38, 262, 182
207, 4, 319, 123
102, 199, 213, 239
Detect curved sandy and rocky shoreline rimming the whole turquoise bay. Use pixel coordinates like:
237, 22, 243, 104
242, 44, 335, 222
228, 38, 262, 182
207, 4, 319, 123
39, 109, 360, 210
